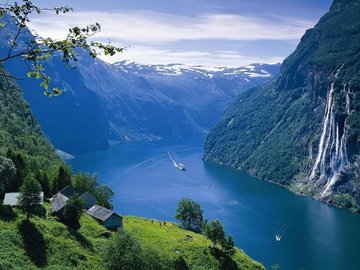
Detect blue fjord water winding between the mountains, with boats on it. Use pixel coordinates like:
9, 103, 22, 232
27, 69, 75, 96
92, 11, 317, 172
69, 137, 360, 269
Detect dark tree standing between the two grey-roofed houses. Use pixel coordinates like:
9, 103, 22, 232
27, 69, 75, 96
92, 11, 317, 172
63, 194, 85, 230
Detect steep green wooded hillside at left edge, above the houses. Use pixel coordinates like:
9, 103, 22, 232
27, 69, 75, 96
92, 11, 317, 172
0, 67, 60, 171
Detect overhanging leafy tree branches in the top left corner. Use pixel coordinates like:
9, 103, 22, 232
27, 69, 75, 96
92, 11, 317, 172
0, 0, 123, 96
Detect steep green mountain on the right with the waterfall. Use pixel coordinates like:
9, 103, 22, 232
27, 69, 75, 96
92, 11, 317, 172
204, 0, 360, 211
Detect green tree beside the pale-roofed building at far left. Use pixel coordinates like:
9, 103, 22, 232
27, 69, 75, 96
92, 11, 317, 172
18, 177, 41, 220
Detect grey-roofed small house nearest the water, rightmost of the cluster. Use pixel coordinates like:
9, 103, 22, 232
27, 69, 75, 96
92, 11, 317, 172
86, 205, 122, 230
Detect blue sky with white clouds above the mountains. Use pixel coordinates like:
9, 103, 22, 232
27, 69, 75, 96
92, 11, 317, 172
29, 0, 332, 67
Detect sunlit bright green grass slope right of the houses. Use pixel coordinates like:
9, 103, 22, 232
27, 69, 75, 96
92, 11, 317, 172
124, 217, 264, 270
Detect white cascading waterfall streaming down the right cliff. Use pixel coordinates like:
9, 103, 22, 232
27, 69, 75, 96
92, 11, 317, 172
309, 77, 351, 198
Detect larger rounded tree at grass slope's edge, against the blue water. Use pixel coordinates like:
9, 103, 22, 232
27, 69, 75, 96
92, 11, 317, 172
175, 198, 204, 232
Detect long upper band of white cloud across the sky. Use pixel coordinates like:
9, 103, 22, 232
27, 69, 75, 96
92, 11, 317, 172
31, 11, 314, 44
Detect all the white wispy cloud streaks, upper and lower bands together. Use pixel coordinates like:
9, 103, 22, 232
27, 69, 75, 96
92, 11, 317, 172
30, 11, 314, 66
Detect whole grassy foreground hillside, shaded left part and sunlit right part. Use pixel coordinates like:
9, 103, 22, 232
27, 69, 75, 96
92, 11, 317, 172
0, 205, 264, 270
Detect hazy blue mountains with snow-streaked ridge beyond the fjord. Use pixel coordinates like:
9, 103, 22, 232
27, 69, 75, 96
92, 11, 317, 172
0, 16, 280, 154
